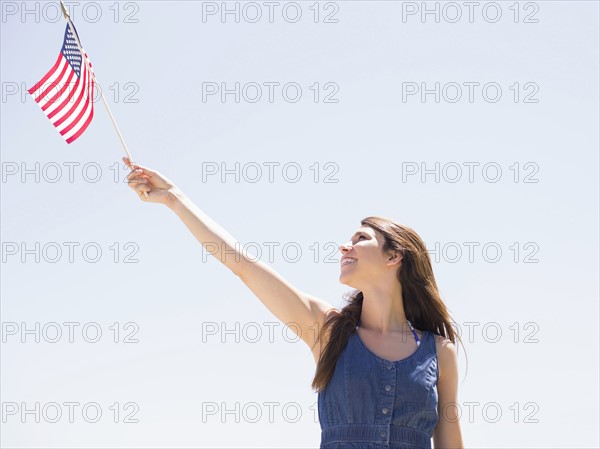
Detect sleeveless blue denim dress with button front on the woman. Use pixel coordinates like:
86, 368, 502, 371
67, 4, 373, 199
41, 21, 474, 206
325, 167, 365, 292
318, 322, 439, 449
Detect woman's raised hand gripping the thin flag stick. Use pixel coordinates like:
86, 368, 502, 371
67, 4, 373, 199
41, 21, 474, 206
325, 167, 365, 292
123, 156, 178, 205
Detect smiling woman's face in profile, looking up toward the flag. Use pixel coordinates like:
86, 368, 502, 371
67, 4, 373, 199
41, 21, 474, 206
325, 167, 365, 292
339, 226, 391, 290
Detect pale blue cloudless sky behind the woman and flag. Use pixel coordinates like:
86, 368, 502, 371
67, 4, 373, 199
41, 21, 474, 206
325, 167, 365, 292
0, 1, 599, 448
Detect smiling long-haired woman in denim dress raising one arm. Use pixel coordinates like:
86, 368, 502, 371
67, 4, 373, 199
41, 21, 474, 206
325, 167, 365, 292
123, 158, 463, 449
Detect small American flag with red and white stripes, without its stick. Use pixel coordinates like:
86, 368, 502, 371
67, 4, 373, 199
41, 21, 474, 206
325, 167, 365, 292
27, 23, 94, 143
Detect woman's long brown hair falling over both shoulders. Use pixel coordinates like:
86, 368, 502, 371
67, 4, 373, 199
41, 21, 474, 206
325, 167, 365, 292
312, 216, 464, 392
